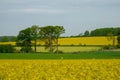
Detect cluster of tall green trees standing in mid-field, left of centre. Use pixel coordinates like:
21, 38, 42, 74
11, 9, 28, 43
17, 25, 65, 53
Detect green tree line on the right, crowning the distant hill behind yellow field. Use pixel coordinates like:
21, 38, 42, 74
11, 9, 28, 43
70, 27, 120, 48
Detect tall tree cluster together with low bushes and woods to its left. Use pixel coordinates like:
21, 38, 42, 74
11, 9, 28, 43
0, 25, 65, 53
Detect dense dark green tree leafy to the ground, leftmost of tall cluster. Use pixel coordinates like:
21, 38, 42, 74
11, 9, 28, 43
17, 28, 32, 53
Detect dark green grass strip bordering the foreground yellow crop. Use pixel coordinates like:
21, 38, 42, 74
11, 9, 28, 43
0, 51, 120, 59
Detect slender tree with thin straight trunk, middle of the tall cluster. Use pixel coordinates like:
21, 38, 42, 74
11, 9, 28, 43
31, 25, 39, 52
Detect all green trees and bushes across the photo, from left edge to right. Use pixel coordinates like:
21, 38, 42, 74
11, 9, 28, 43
0, 25, 120, 53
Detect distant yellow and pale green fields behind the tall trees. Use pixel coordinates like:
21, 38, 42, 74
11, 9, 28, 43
0, 36, 118, 52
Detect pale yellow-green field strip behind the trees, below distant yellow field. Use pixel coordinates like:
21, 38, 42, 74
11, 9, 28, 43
16, 46, 102, 53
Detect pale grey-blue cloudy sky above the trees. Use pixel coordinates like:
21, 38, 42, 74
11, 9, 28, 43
0, 0, 120, 36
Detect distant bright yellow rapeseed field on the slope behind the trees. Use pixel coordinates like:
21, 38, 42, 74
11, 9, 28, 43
0, 36, 118, 45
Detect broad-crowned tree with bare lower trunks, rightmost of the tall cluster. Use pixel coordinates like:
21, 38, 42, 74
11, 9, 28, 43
40, 26, 65, 52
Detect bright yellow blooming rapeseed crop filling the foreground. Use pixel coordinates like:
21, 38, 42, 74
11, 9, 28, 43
0, 59, 120, 80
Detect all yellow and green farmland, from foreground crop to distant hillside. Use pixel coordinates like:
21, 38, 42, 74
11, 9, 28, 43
0, 37, 120, 80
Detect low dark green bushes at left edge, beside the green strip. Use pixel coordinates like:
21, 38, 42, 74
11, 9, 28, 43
0, 45, 15, 53
